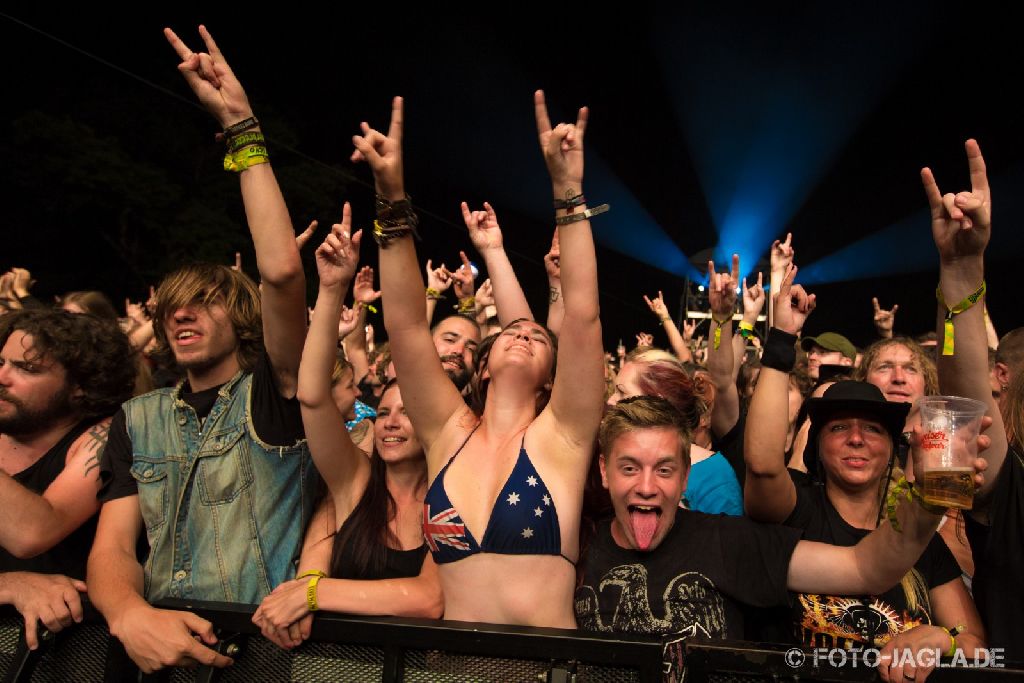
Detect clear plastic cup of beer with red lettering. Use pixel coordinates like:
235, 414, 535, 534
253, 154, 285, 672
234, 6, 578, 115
918, 396, 988, 510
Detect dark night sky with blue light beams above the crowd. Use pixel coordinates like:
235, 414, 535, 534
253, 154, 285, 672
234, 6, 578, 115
0, 9, 1024, 348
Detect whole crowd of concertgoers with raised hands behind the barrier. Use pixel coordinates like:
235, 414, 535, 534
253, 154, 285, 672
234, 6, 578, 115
0, 27, 1024, 681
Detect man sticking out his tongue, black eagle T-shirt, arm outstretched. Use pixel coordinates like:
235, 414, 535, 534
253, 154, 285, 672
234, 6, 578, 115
574, 396, 987, 679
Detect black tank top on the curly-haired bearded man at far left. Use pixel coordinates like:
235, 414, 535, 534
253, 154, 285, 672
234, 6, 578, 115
0, 420, 98, 580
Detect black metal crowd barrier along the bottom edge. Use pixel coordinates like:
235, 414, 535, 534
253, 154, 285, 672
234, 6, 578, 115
0, 601, 1024, 683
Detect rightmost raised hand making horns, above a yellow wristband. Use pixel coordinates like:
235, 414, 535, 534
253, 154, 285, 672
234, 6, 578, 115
921, 139, 992, 263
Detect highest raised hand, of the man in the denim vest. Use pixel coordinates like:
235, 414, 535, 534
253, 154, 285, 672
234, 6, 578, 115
164, 26, 253, 128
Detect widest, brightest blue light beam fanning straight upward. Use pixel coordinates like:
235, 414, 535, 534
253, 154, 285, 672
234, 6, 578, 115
655, 6, 921, 275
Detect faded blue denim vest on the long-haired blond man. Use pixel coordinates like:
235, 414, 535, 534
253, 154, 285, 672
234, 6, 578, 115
124, 373, 316, 604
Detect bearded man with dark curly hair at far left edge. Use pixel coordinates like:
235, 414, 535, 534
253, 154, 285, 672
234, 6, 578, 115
0, 308, 135, 649
